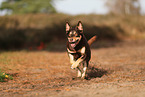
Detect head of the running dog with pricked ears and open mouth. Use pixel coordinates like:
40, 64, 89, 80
66, 21, 83, 48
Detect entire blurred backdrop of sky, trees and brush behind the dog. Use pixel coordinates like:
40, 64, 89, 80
0, 0, 145, 50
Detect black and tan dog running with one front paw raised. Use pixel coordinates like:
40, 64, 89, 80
65, 21, 96, 79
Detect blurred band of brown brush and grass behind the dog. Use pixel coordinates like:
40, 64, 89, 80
0, 14, 145, 49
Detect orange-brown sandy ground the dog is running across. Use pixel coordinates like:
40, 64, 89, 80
0, 40, 145, 97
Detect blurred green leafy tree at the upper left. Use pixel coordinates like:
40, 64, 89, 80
0, 0, 56, 14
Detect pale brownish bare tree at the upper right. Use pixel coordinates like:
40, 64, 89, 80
106, 0, 141, 15
